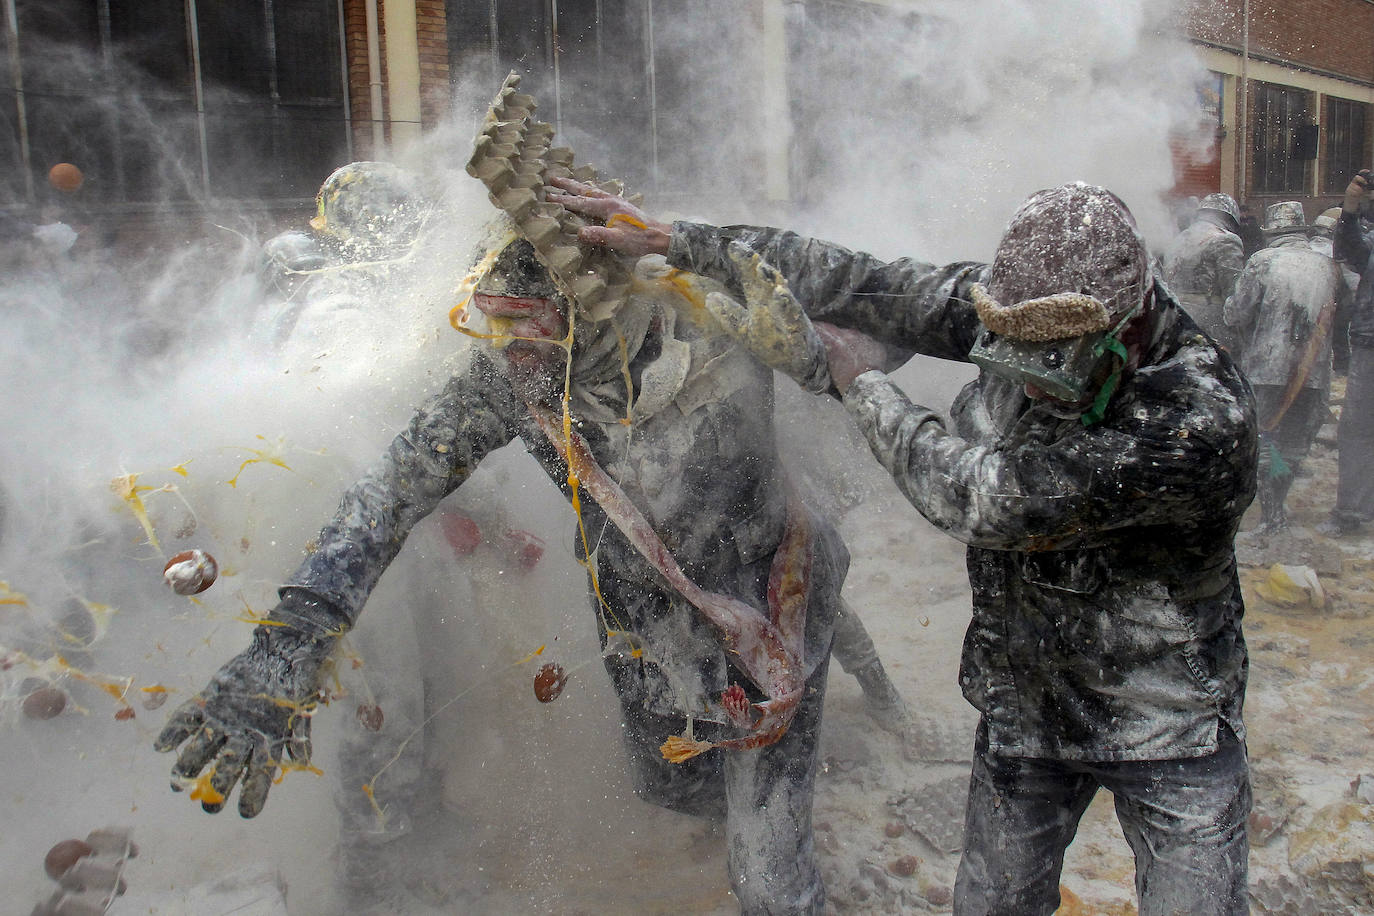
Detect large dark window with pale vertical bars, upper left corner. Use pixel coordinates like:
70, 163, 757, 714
0, 0, 348, 203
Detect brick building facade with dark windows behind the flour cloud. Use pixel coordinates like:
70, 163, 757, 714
0, 0, 1374, 233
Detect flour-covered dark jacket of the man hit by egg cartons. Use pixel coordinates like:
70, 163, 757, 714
286, 258, 849, 721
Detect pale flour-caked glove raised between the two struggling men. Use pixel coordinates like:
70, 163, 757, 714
706, 242, 830, 394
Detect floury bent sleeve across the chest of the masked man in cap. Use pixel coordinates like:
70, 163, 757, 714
845, 351, 1253, 549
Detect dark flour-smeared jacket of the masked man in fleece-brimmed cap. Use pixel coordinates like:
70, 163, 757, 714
668, 222, 1256, 761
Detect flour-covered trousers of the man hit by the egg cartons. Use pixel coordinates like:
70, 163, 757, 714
606, 652, 830, 916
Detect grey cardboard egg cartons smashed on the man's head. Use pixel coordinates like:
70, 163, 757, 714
467, 73, 631, 320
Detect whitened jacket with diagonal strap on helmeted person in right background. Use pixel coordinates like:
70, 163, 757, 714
1226, 233, 1348, 391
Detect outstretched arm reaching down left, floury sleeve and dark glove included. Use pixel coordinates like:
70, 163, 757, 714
154, 358, 525, 817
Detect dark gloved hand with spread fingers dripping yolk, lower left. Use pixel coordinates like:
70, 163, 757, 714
153, 592, 348, 817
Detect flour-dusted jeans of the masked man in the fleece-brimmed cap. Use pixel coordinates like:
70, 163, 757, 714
954, 725, 1250, 916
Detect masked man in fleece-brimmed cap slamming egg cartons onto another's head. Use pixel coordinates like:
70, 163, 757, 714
552, 184, 1256, 915
